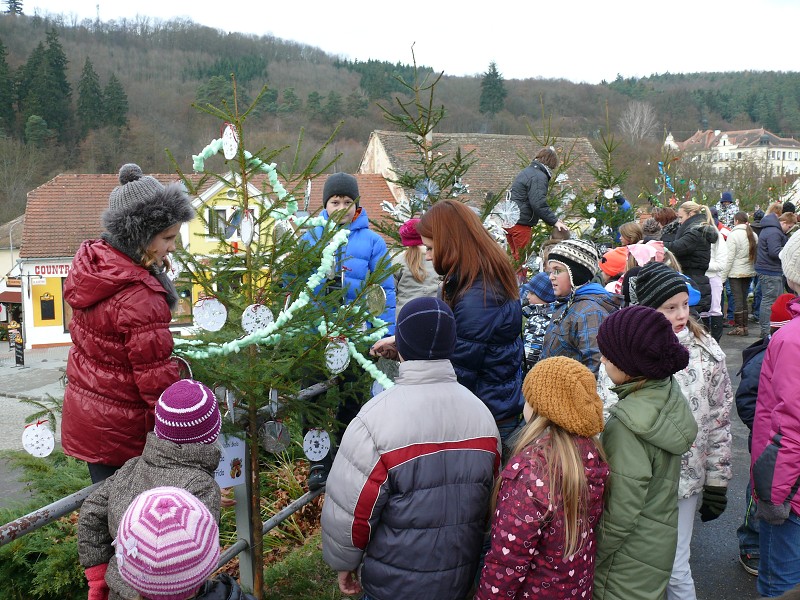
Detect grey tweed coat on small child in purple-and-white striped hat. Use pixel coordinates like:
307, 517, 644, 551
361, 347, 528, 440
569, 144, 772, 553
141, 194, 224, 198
78, 432, 220, 600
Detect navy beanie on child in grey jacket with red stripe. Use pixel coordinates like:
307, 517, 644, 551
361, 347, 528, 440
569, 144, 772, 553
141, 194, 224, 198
394, 297, 456, 360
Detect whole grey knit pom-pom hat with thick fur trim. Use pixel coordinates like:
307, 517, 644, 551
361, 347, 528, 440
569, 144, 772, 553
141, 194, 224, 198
102, 163, 195, 263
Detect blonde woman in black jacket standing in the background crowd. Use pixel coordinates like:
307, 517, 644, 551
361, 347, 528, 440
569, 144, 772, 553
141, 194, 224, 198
662, 200, 722, 313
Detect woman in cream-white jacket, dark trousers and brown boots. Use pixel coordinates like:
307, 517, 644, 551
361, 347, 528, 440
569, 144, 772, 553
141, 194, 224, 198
722, 211, 758, 335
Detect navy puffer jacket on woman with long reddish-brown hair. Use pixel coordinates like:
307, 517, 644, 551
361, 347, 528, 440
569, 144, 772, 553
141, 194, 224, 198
450, 279, 523, 421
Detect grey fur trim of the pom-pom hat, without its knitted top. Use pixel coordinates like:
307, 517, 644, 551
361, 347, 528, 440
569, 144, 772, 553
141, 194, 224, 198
103, 183, 195, 262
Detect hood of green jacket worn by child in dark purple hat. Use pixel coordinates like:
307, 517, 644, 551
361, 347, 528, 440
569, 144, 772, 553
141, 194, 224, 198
609, 377, 697, 455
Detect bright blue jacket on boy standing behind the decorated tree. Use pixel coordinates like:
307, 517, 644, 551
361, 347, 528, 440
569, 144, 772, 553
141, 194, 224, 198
302, 208, 396, 335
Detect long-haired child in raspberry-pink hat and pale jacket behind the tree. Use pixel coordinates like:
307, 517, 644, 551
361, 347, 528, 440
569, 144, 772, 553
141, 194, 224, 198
392, 219, 442, 314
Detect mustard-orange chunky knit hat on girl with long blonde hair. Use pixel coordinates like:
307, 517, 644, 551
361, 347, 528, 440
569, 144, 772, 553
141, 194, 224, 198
522, 356, 603, 437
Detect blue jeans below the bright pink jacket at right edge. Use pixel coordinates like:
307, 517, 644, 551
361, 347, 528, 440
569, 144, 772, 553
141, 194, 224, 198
756, 513, 800, 598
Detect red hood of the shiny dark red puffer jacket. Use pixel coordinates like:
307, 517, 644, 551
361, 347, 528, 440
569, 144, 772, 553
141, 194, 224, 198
64, 240, 167, 309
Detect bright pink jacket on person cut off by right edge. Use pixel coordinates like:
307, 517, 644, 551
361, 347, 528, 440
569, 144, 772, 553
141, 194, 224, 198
751, 298, 800, 515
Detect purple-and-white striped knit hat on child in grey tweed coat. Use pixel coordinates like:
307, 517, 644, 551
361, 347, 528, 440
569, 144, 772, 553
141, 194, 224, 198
155, 379, 222, 444
